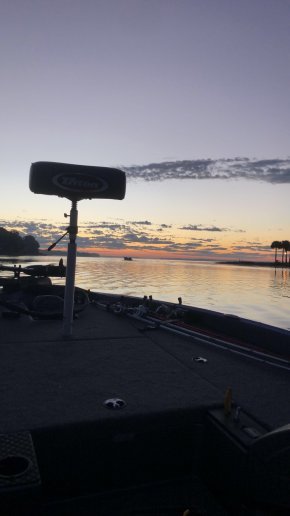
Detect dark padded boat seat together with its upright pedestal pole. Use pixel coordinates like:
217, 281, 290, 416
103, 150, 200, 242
29, 161, 126, 338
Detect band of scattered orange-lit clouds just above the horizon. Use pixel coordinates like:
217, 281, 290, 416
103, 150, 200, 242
0, 219, 270, 259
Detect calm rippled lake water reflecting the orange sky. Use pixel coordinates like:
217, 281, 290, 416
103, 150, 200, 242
0, 256, 290, 329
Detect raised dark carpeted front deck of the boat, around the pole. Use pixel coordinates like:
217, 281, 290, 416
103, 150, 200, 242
0, 306, 290, 433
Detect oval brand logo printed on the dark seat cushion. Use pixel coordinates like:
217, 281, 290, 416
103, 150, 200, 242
53, 174, 108, 193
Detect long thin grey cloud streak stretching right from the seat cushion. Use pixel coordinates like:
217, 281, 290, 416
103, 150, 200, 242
123, 158, 290, 184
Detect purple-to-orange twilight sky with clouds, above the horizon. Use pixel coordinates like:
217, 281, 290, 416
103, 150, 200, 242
0, 0, 290, 260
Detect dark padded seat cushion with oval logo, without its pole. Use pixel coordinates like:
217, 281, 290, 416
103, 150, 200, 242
29, 161, 126, 201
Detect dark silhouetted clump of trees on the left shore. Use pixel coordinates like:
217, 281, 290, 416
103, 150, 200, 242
0, 228, 39, 256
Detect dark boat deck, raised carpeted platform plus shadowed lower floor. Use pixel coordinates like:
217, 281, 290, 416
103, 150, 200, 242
0, 305, 290, 516
